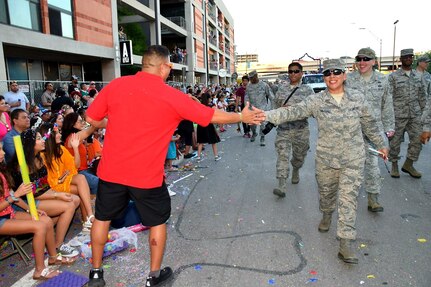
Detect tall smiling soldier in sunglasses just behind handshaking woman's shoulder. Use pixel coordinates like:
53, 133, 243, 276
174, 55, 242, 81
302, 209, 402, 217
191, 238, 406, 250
346, 48, 395, 212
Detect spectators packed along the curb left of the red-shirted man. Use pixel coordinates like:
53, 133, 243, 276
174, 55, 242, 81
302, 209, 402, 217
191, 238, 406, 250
0, 76, 104, 280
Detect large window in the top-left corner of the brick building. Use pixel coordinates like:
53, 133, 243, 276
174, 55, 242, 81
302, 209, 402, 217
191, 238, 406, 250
0, 0, 41, 31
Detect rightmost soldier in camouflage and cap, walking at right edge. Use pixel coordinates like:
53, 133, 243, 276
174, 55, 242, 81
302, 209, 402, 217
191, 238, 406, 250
388, 49, 427, 178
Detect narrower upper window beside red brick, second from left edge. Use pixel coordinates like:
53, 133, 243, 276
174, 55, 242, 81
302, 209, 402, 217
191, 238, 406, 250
48, 0, 73, 39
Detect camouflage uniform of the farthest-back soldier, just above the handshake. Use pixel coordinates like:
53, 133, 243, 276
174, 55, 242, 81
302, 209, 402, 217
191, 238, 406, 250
245, 80, 274, 136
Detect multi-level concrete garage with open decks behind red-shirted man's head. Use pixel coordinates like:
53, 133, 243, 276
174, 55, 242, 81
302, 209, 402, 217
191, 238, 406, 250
118, 0, 235, 84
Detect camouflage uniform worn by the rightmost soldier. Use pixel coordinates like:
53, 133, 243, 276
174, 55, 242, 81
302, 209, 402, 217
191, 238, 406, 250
388, 69, 427, 162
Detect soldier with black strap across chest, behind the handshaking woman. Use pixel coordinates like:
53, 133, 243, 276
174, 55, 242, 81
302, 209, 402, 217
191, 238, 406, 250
273, 62, 314, 197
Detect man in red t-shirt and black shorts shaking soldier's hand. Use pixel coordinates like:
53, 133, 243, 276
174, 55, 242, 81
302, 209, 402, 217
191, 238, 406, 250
87, 45, 264, 287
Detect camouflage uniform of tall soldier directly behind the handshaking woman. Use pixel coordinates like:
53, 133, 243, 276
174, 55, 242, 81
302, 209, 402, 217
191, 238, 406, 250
346, 71, 395, 194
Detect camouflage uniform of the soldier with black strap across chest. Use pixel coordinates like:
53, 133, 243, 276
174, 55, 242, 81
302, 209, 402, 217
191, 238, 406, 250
274, 84, 314, 178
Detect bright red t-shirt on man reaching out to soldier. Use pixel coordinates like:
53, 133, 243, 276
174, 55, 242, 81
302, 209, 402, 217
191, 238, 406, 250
87, 72, 214, 188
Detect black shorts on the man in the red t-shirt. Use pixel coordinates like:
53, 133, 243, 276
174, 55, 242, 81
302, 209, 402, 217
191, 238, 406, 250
95, 179, 171, 226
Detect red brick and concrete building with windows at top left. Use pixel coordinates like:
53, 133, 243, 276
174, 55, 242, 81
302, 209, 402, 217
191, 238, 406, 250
0, 0, 120, 85
